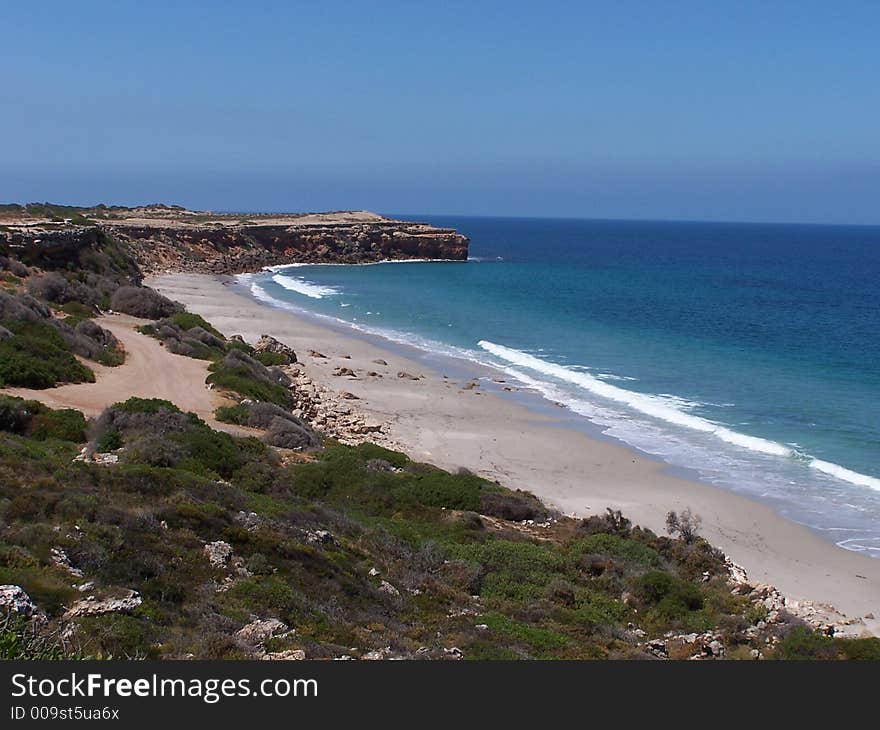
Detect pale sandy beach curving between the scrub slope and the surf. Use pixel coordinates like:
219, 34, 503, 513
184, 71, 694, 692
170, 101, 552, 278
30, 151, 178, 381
146, 274, 880, 633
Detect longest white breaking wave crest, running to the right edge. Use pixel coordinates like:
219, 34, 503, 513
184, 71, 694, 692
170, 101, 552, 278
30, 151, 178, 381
477, 340, 880, 491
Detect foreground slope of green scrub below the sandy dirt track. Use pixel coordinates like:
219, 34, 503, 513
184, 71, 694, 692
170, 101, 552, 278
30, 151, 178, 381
0, 398, 878, 659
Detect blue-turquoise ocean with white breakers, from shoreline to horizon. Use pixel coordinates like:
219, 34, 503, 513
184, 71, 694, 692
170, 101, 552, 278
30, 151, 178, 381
245, 216, 880, 557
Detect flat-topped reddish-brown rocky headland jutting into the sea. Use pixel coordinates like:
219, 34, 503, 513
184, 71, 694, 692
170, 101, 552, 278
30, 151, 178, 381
0, 204, 468, 275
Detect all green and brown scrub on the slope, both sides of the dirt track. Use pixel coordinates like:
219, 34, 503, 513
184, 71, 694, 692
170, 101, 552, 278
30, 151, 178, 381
0, 235, 880, 659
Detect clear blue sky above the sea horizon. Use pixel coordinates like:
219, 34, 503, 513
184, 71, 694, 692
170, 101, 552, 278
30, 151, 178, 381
0, 0, 880, 224
